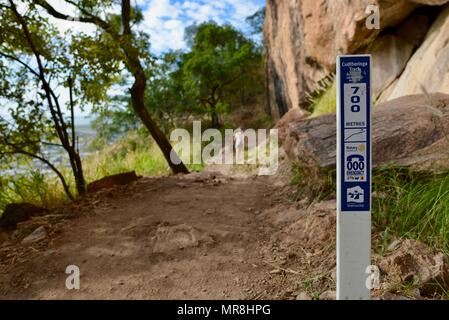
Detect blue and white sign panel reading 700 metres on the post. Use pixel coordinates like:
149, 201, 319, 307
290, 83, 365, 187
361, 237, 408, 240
337, 55, 371, 212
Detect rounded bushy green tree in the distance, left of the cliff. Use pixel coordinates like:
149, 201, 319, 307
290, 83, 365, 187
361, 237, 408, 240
180, 22, 263, 128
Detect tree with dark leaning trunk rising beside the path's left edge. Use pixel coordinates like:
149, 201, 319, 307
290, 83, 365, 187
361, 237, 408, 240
34, 0, 188, 173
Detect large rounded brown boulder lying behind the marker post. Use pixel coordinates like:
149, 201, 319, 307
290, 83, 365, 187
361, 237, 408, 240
283, 94, 449, 171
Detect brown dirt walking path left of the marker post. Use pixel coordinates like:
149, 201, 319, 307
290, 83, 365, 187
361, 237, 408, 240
0, 173, 308, 299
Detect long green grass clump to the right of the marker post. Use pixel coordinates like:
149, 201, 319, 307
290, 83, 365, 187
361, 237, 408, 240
373, 168, 449, 254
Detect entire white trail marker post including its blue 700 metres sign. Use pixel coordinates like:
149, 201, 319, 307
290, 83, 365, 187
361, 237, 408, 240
337, 55, 372, 300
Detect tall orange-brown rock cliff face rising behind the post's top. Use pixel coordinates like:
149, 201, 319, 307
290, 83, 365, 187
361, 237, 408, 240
264, 0, 449, 118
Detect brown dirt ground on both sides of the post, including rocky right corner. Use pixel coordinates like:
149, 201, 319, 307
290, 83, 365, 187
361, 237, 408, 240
0, 170, 449, 300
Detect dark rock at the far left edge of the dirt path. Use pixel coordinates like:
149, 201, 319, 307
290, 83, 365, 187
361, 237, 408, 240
0, 203, 47, 230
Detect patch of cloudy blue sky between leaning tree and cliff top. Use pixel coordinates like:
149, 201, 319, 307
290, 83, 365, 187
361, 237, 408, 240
137, 0, 265, 53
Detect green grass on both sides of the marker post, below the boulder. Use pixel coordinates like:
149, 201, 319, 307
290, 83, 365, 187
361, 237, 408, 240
292, 166, 449, 253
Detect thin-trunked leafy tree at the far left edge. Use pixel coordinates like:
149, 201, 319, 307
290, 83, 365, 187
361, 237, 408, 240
0, 0, 86, 199
